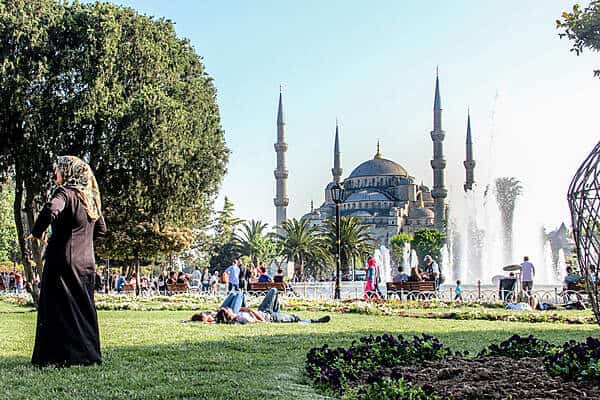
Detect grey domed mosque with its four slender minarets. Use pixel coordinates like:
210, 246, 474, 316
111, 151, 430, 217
274, 77, 475, 245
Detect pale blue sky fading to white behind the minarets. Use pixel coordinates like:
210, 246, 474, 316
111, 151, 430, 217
98, 0, 600, 226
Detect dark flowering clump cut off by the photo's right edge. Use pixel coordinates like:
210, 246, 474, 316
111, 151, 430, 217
544, 337, 600, 383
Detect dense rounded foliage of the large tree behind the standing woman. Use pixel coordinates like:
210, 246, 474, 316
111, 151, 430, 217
0, 0, 228, 300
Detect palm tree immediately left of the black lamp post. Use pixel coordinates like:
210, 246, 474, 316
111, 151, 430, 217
273, 218, 330, 276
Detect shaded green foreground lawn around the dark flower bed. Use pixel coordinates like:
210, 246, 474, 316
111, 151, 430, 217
0, 319, 599, 400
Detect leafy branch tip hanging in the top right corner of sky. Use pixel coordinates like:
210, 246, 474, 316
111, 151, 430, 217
556, 0, 600, 78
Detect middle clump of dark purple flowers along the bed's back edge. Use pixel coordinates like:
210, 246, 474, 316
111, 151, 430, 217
477, 335, 556, 358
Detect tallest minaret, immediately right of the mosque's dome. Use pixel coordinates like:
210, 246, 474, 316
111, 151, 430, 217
431, 70, 448, 231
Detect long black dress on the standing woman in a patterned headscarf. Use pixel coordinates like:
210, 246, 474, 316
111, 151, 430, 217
31, 187, 106, 366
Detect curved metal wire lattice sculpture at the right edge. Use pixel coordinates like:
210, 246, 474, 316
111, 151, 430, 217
567, 142, 600, 325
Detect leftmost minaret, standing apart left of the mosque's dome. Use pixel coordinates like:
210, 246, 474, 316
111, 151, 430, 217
273, 86, 290, 226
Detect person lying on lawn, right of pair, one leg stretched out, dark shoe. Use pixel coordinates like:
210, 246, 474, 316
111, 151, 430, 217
215, 288, 331, 324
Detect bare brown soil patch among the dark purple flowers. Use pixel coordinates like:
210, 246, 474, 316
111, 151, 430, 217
359, 357, 600, 400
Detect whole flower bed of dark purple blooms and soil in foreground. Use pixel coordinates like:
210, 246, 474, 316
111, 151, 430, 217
306, 335, 600, 400
